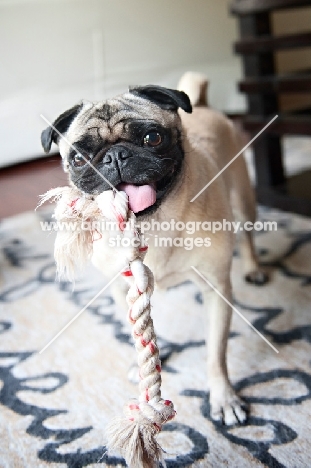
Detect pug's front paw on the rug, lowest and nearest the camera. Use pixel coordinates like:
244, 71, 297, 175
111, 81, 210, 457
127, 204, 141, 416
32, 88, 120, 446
210, 394, 247, 426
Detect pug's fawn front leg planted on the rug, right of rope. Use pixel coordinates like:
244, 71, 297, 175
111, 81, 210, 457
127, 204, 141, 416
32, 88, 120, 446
203, 279, 246, 425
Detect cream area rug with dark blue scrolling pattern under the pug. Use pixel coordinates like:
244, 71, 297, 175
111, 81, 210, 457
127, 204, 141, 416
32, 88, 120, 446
0, 209, 311, 468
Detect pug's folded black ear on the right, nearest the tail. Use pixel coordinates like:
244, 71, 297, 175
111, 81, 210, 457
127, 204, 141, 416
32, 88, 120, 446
129, 85, 192, 114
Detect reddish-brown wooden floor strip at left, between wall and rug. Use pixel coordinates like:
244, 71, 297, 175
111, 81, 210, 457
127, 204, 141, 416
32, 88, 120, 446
0, 155, 67, 219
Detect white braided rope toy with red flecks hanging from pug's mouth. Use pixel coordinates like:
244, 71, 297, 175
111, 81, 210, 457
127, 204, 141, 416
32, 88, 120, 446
39, 187, 176, 468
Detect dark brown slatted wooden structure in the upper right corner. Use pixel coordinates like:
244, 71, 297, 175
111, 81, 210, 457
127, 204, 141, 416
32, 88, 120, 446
231, 0, 311, 216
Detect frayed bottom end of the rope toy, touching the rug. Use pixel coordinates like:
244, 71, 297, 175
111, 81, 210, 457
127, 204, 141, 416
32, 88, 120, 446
105, 416, 166, 468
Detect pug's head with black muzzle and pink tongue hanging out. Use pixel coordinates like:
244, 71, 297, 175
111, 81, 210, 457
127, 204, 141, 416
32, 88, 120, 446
41, 85, 192, 215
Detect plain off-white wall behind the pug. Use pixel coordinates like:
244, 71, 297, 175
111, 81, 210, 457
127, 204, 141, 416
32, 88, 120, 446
0, 0, 245, 165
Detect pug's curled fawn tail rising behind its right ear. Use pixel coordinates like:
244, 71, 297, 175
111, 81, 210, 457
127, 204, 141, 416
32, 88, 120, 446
177, 72, 208, 106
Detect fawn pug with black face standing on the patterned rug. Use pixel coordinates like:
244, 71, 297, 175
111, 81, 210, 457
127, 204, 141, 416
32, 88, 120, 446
41, 75, 267, 425
